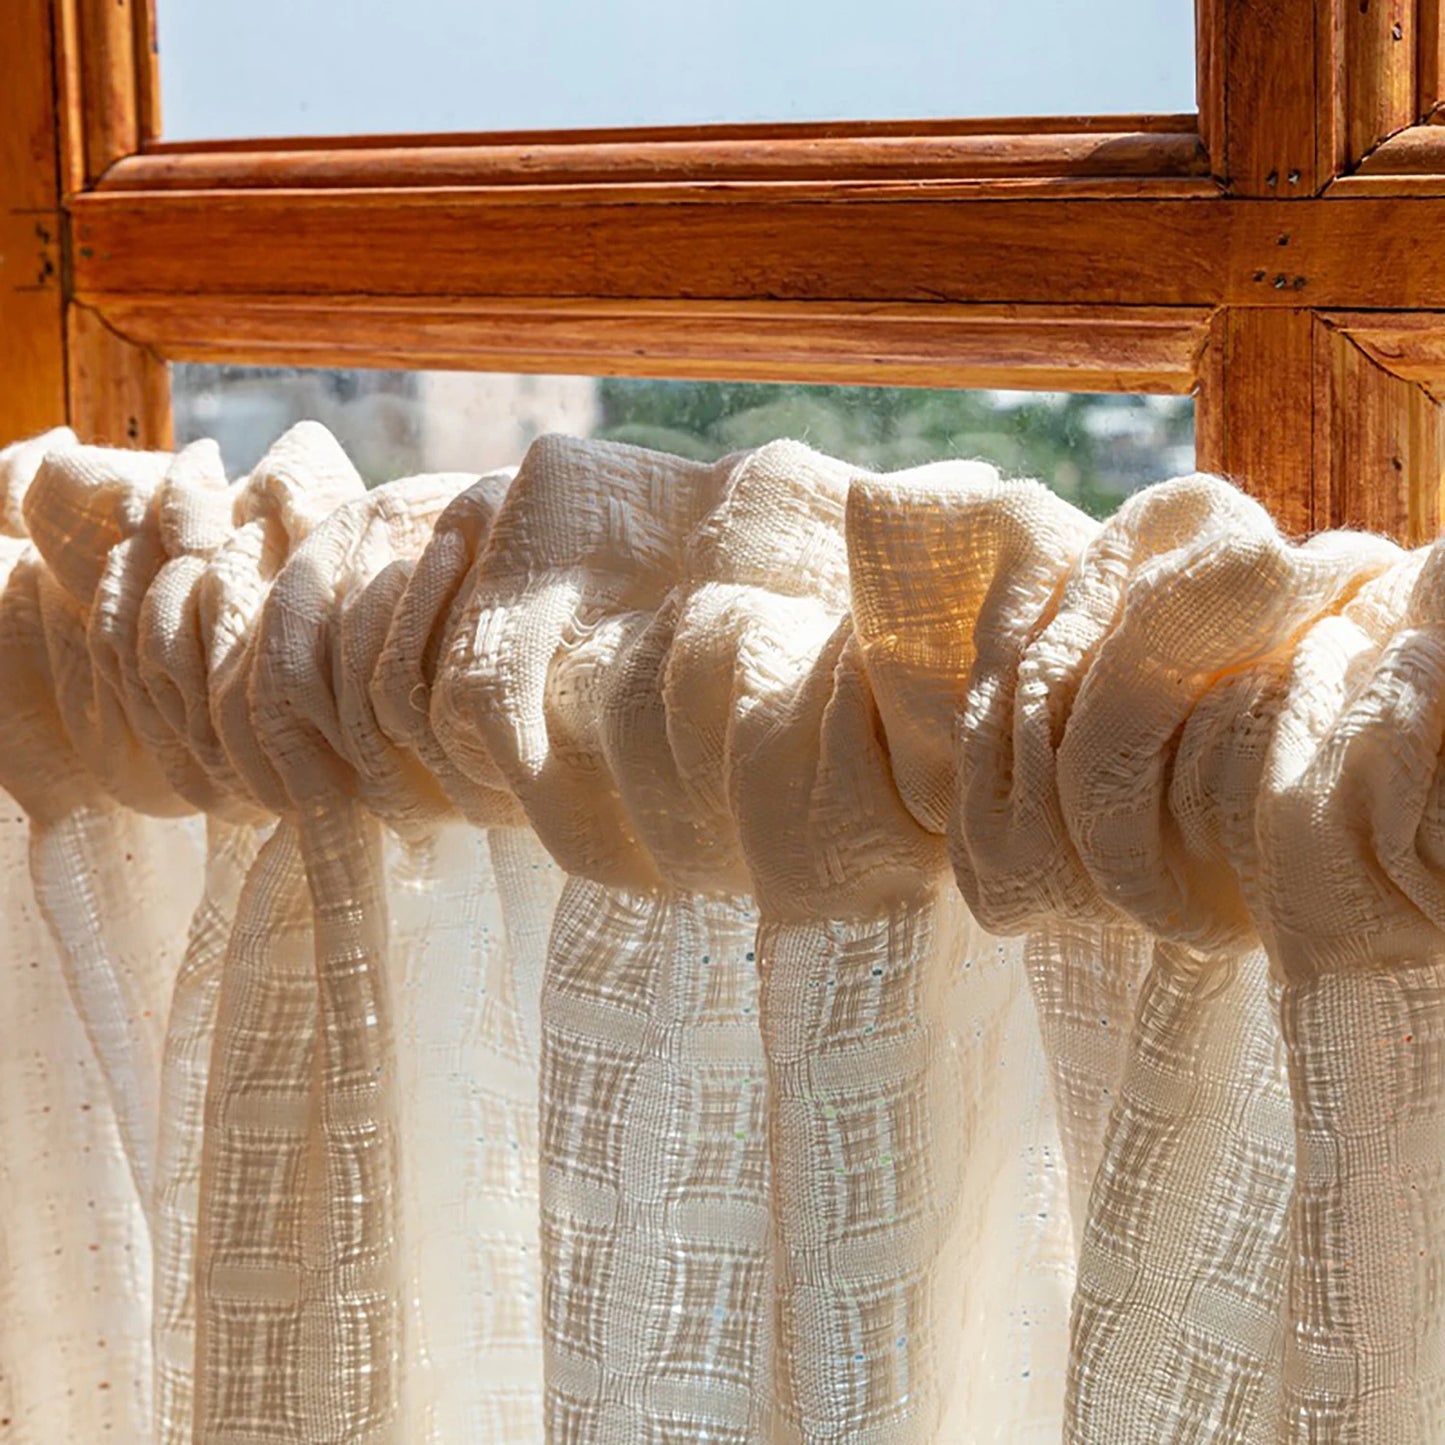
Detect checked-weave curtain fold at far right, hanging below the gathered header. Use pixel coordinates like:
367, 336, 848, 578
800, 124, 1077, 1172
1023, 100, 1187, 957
1282, 957, 1445, 1441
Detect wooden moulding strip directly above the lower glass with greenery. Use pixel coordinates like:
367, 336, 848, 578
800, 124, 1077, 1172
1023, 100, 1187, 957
90, 296, 1209, 393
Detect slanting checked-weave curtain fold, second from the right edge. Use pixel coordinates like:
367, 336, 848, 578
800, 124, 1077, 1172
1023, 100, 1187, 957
1068, 944, 1293, 1441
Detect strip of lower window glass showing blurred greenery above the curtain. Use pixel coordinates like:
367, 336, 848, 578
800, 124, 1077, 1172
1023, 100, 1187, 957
172, 366, 1194, 516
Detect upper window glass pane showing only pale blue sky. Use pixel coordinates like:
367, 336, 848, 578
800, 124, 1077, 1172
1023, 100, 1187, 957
159, 0, 1195, 140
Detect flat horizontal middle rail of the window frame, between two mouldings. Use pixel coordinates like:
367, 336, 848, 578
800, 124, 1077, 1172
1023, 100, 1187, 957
71, 191, 1445, 308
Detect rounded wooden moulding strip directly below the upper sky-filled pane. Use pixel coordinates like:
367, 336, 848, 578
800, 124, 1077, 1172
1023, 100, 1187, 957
100, 129, 1208, 191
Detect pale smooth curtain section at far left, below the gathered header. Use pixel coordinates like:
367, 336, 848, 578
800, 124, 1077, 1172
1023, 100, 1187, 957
0, 801, 152, 1442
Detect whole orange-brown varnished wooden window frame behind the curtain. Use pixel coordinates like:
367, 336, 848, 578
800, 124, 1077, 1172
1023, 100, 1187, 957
8, 0, 1445, 540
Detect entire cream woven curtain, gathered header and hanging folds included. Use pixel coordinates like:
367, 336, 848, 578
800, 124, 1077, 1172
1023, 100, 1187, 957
0, 423, 1445, 1445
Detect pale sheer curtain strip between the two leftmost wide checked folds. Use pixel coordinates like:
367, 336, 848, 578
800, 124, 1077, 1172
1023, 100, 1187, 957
387, 825, 561, 1442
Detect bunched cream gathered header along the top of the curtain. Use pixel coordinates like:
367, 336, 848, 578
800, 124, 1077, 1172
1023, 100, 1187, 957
0, 423, 1445, 972
